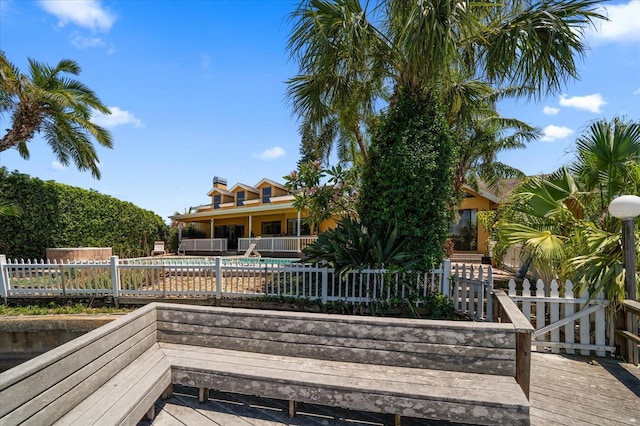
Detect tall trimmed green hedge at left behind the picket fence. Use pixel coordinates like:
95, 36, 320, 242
0, 168, 169, 259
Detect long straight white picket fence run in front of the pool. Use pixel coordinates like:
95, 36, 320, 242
0, 255, 451, 304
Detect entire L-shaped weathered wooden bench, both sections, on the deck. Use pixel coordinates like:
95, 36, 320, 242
0, 303, 529, 425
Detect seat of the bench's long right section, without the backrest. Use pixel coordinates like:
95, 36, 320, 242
160, 342, 529, 425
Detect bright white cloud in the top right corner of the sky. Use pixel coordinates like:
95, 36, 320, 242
588, 0, 640, 43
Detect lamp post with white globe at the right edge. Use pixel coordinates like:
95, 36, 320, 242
609, 195, 640, 300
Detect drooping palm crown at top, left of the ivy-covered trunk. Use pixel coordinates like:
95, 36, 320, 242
287, 0, 388, 163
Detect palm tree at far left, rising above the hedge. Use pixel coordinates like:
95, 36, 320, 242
0, 52, 112, 179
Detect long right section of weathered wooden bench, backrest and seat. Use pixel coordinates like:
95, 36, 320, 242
157, 305, 529, 425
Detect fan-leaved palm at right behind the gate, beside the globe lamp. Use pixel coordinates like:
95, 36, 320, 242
497, 118, 640, 301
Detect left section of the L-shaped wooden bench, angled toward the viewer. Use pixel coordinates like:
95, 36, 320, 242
0, 306, 171, 425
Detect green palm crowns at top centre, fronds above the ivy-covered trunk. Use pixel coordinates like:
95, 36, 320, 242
288, 0, 604, 160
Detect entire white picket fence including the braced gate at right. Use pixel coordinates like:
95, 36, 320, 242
0, 255, 615, 356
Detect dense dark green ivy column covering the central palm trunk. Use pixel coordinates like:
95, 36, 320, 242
357, 90, 454, 270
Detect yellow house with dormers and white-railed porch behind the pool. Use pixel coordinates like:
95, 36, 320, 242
171, 176, 516, 255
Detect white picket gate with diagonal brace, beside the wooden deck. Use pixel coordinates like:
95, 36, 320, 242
508, 280, 615, 356
